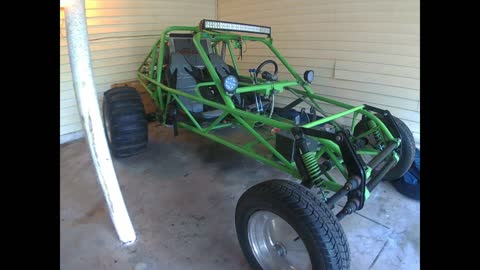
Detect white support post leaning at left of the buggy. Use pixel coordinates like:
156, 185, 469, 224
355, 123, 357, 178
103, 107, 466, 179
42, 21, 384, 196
64, 0, 136, 244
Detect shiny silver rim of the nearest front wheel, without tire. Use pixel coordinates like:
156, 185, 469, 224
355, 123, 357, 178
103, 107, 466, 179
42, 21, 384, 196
247, 210, 312, 270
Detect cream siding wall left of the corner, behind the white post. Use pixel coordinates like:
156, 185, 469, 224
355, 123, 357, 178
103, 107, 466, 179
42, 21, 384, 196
60, 0, 217, 142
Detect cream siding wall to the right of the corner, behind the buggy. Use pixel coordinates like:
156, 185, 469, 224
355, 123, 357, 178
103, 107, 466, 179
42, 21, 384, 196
218, 0, 420, 147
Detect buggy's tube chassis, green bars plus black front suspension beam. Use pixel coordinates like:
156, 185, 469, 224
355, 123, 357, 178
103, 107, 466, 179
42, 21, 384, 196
137, 22, 401, 219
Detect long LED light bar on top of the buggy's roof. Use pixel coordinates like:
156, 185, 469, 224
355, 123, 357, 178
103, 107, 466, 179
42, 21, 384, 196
200, 19, 272, 36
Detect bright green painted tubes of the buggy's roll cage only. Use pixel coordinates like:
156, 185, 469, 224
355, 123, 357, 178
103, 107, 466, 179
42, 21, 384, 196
137, 26, 401, 198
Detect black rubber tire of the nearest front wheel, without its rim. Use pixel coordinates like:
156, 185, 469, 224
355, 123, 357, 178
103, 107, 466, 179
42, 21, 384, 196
235, 180, 350, 270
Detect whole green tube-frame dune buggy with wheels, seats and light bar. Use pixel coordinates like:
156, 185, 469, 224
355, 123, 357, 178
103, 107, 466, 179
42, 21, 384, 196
103, 20, 415, 269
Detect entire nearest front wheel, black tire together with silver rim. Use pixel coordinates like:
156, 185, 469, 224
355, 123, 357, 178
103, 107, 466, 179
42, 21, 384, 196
235, 180, 350, 270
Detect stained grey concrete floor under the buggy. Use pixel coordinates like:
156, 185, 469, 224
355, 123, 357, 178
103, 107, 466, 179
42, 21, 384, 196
60, 124, 420, 270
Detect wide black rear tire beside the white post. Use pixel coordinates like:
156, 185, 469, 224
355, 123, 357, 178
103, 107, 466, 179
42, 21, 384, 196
103, 87, 148, 158
